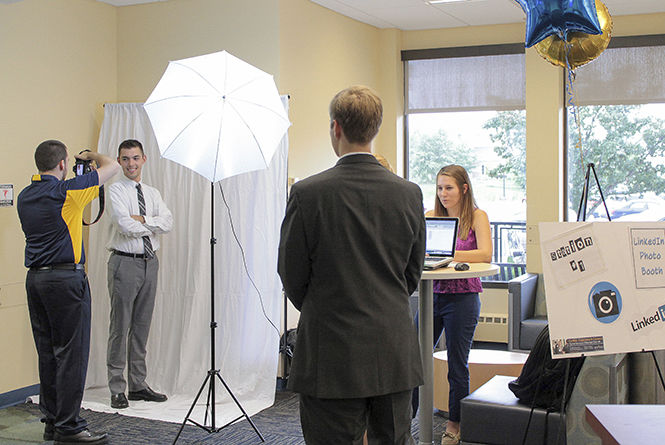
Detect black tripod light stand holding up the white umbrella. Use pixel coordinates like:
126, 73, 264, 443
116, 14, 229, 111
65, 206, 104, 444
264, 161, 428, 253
173, 182, 265, 445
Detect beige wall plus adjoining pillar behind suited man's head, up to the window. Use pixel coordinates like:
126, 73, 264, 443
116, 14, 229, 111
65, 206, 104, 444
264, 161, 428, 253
279, 0, 403, 179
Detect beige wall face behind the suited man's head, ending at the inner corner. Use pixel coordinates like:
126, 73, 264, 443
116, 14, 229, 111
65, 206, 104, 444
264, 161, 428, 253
279, 0, 386, 179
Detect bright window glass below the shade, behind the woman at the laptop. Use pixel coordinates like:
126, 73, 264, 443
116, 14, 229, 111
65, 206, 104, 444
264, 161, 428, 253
408, 110, 526, 263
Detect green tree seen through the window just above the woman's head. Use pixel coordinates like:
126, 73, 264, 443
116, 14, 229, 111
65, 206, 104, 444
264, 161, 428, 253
409, 129, 478, 184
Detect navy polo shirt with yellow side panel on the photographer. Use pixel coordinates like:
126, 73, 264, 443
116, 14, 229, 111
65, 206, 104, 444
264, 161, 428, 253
16, 171, 99, 267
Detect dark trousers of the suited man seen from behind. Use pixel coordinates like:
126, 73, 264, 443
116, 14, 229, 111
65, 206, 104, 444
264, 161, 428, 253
300, 390, 415, 445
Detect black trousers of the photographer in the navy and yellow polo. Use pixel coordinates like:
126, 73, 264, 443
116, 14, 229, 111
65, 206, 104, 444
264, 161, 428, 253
25, 270, 90, 435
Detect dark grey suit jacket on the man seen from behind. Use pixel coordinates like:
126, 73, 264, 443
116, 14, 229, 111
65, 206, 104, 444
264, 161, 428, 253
279, 154, 425, 399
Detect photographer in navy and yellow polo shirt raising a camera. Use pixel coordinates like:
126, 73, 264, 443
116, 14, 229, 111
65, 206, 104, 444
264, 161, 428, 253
17, 140, 120, 445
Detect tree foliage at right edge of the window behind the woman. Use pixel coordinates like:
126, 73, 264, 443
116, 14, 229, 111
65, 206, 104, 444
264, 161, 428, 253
483, 110, 526, 190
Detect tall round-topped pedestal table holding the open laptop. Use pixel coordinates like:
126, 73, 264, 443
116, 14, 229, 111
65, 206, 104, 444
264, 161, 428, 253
418, 263, 499, 445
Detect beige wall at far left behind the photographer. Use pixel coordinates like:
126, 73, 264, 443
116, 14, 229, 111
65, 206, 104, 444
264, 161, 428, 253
0, 0, 116, 393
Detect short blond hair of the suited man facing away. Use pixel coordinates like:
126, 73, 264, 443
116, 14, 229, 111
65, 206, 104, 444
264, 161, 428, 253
329, 85, 383, 145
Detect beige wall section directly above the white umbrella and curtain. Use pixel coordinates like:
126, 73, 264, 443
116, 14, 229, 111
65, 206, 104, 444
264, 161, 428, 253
117, 0, 283, 102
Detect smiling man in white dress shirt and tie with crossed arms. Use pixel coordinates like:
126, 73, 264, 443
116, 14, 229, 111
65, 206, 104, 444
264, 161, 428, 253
106, 139, 173, 409
